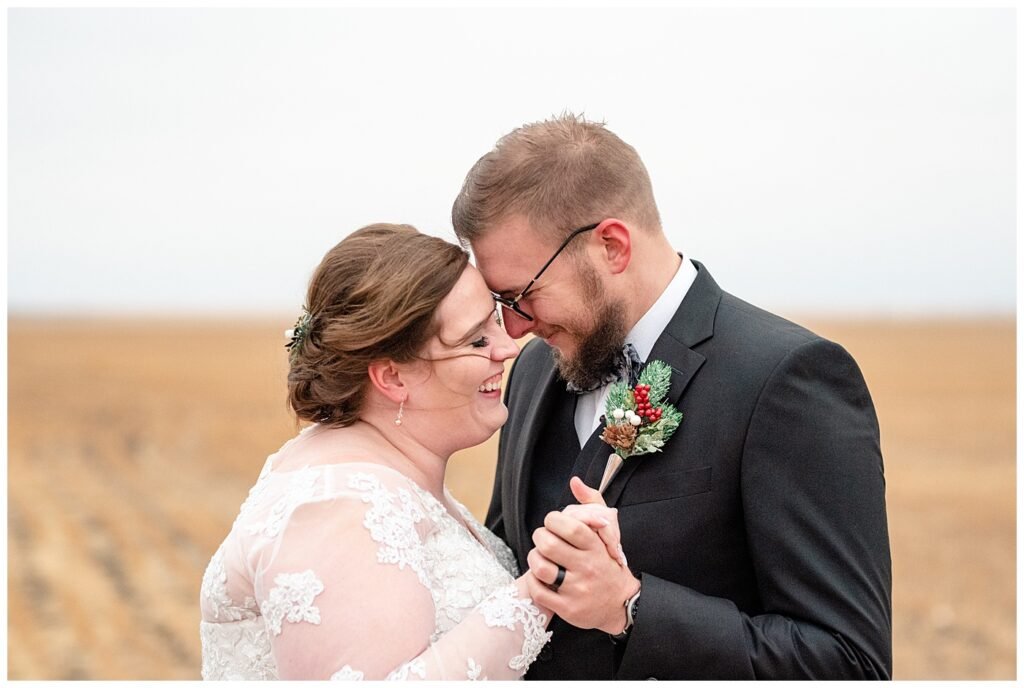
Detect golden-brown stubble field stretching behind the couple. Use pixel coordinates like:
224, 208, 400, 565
7, 318, 1016, 679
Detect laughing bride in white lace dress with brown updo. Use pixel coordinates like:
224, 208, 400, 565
200, 224, 618, 680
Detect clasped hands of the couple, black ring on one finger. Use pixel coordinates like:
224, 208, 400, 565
526, 477, 640, 634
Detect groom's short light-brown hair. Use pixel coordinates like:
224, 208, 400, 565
452, 113, 662, 248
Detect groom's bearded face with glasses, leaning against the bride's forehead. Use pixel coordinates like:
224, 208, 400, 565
472, 217, 626, 384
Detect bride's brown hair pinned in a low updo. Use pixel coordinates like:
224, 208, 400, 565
288, 223, 469, 427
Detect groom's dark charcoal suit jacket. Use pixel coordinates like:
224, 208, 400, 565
486, 261, 892, 679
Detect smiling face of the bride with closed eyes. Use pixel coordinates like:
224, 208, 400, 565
406, 265, 519, 452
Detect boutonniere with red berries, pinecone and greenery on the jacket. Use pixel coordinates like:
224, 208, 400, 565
600, 360, 683, 491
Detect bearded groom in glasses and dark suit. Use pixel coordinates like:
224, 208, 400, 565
452, 116, 892, 680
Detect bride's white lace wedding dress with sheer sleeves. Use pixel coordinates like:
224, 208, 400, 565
200, 429, 550, 680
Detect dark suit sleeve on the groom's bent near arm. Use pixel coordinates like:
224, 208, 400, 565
617, 339, 892, 679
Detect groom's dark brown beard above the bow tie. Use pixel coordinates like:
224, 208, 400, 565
554, 272, 629, 389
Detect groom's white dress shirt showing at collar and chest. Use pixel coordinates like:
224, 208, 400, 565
574, 254, 697, 447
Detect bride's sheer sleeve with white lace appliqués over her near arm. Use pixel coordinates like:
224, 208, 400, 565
253, 471, 550, 680
